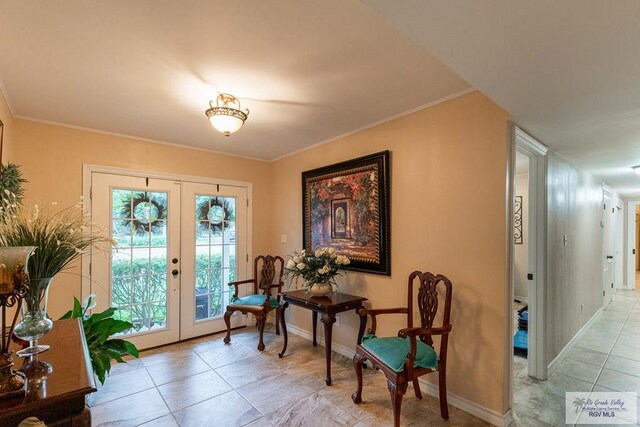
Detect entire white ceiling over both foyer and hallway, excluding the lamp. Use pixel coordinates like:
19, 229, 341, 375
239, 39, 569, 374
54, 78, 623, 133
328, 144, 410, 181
0, 0, 640, 196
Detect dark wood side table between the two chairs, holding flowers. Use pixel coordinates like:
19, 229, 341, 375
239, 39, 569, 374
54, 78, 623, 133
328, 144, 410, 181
278, 289, 367, 385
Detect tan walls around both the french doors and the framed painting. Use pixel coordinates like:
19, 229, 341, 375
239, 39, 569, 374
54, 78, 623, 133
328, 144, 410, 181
5, 92, 510, 413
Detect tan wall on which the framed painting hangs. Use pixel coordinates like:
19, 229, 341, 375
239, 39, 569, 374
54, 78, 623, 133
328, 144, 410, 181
271, 92, 510, 413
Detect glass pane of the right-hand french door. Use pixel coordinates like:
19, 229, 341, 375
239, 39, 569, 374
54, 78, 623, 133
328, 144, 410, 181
195, 194, 236, 320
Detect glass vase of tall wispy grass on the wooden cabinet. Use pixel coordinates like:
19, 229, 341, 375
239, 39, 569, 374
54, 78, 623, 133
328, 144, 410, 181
0, 203, 113, 356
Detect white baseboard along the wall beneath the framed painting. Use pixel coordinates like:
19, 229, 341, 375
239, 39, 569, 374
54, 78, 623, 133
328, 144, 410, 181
287, 325, 512, 427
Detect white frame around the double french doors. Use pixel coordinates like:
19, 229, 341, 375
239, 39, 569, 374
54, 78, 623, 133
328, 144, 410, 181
81, 163, 253, 314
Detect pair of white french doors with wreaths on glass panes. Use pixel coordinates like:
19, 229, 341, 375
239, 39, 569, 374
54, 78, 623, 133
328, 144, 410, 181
90, 172, 247, 348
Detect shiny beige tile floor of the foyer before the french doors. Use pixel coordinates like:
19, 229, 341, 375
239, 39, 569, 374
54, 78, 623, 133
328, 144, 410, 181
89, 327, 488, 427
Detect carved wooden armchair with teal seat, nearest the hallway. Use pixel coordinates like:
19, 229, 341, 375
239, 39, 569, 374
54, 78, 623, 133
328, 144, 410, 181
351, 271, 452, 427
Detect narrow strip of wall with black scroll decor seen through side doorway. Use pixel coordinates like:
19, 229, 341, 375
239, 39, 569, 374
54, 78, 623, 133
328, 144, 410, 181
513, 173, 530, 298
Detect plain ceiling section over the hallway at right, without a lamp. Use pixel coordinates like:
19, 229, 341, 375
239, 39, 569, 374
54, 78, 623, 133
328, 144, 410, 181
363, 0, 640, 196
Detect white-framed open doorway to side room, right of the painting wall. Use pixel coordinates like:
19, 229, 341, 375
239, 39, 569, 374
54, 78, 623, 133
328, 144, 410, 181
507, 125, 548, 424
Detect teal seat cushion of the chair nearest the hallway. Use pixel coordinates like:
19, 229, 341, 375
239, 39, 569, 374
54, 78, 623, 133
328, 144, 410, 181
362, 335, 438, 372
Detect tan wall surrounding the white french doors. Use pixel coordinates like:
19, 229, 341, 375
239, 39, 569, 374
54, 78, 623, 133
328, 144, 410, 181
5, 119, 273, 318
